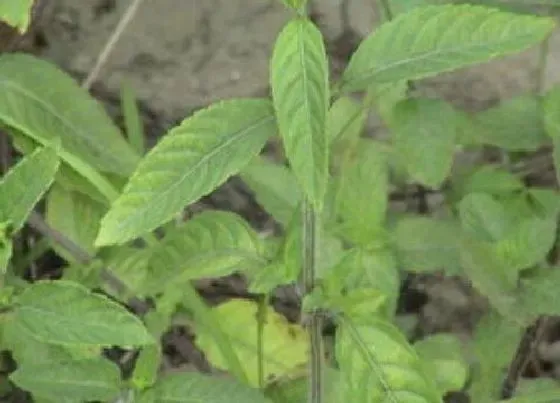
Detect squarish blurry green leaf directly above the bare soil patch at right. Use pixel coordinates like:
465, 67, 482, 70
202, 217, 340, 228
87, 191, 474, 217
393, 217, 461, 273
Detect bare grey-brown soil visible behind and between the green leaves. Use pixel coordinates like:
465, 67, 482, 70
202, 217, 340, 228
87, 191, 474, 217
0, 0, 560, 402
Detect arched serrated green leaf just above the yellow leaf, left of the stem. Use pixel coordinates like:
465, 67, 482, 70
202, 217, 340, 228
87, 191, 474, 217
148, 211, 265, 295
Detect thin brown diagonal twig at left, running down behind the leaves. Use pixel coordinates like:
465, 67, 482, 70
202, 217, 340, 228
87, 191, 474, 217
27, 211, 150, 315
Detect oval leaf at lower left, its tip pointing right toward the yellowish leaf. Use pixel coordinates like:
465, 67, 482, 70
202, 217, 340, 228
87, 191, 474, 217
15, 280, 154, 346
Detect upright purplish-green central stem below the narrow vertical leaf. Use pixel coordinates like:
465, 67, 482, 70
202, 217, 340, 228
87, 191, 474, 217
302, 200, 324, 403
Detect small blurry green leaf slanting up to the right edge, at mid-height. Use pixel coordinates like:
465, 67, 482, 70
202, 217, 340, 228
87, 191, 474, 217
496, 217, 556, 270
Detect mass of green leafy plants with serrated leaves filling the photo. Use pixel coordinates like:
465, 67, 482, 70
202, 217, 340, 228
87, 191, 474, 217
0, 0, 560, 403
